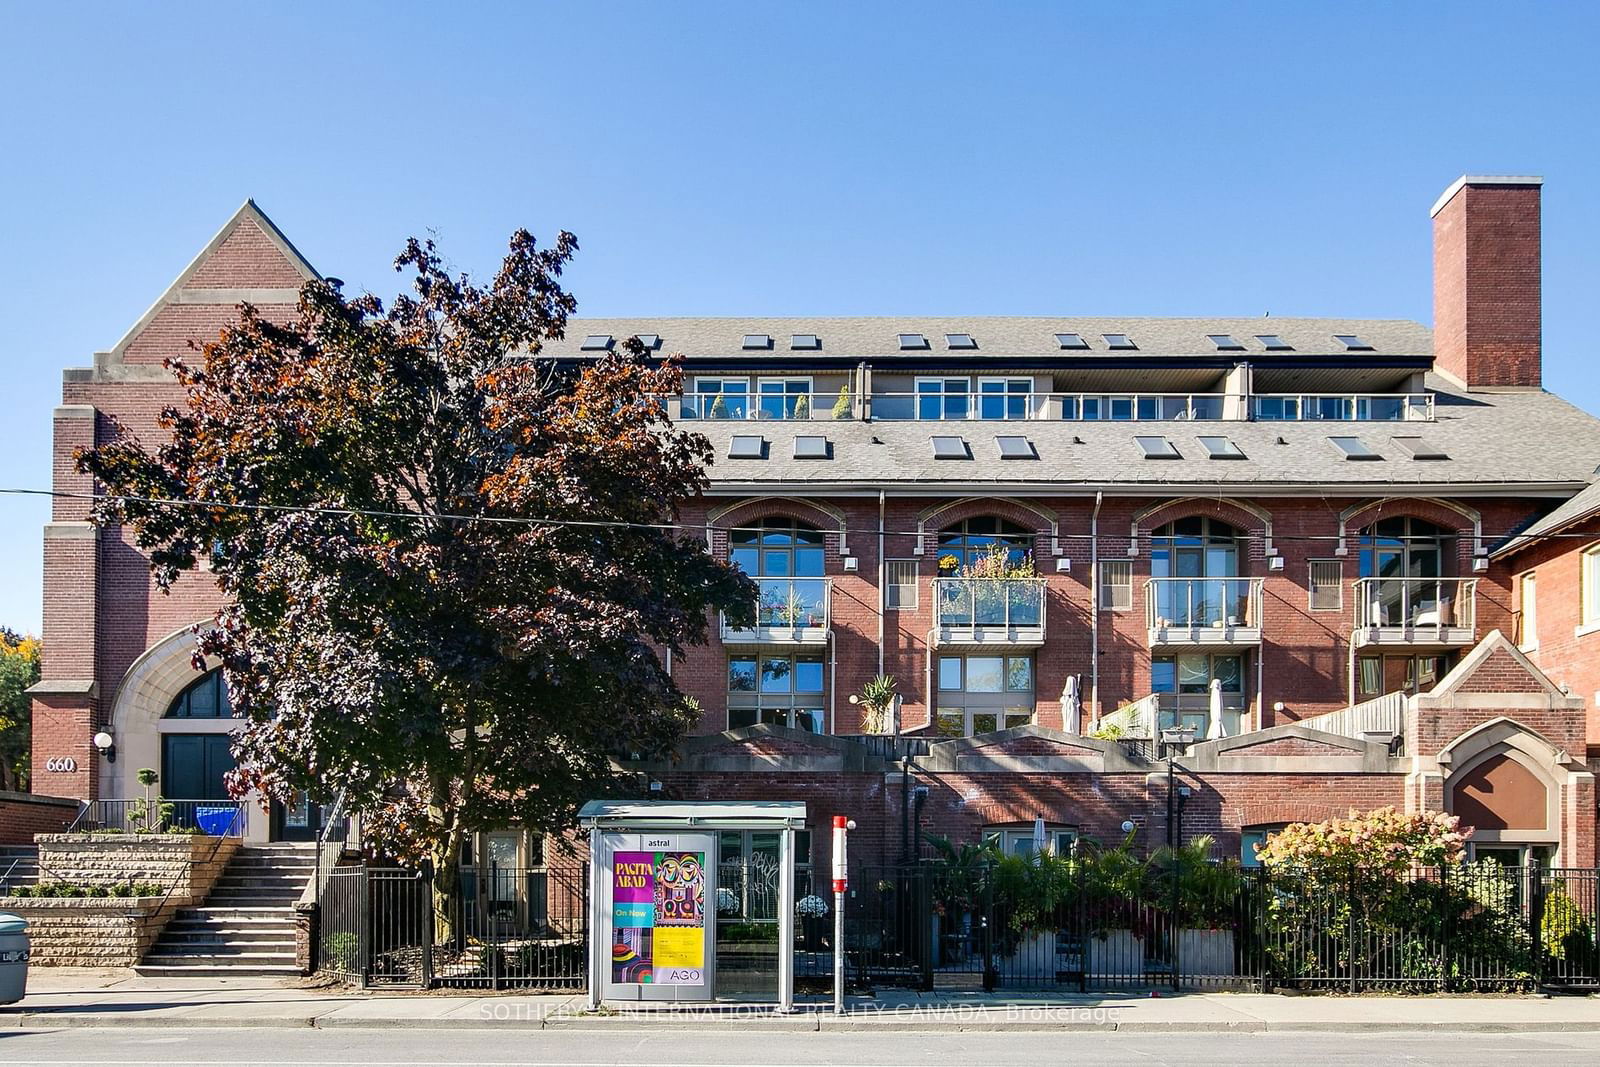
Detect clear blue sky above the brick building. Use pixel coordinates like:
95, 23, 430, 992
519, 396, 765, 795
0, 0, 1600, 629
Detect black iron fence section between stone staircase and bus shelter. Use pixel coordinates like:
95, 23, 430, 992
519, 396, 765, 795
317, 861, 589, 990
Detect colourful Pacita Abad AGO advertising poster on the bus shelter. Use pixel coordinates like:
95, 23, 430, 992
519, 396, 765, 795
611, 851, 706, 985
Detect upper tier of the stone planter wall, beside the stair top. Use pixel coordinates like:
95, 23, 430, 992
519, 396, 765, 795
35, 833, 238, 904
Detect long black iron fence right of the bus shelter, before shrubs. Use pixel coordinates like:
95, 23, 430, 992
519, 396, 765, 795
838, 864, 1600, 992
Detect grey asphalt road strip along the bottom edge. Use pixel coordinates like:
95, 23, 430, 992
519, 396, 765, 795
0, 1027, 1600, 1067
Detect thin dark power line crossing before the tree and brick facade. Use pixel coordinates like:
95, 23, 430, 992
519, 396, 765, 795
0, 488, 1595, 544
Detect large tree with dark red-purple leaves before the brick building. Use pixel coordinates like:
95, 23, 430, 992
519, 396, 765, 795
78, 232, 755, 921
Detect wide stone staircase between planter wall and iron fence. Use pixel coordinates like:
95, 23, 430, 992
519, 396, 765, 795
134, 843, 317, 977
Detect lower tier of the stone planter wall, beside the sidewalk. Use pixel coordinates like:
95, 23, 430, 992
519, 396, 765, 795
0, 896, 178, 966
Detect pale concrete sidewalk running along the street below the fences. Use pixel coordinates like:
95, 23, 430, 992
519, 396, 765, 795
0, 968, 1600, 1033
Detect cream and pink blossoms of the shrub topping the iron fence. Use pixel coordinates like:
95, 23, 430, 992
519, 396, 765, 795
1256, 806, 1472, 873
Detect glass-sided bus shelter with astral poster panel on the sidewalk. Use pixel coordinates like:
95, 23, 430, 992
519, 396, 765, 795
578, 800, 805, 1011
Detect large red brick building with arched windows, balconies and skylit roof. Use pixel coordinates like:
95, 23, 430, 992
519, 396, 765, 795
21, 178, 1600, 864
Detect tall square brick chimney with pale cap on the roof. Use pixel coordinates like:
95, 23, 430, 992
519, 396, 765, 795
1432, 174, 1544, 389
